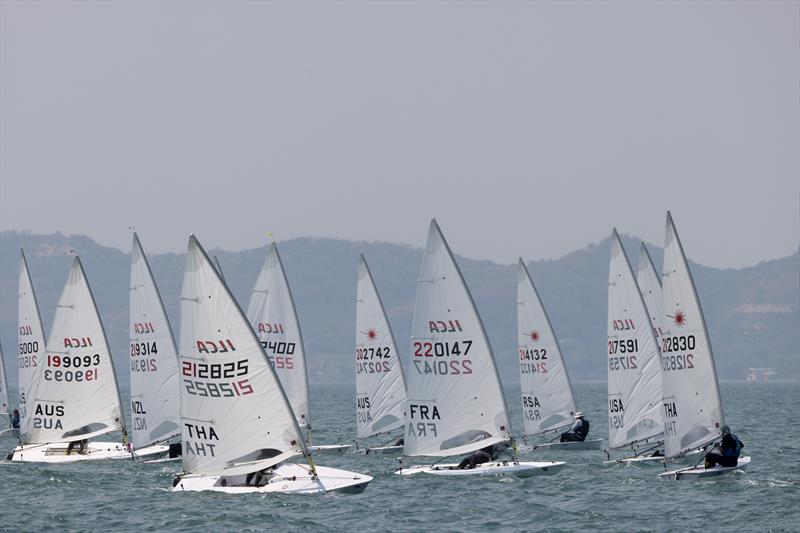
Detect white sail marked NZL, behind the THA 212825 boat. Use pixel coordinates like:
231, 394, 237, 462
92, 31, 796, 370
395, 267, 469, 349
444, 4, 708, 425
130, 233, 181, 449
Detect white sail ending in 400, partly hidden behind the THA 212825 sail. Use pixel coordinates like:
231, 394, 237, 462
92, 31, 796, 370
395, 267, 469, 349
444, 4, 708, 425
247, 243, 311, 427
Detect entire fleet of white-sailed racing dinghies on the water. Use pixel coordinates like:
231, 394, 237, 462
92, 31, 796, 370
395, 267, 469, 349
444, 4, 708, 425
0, 212, 751, 486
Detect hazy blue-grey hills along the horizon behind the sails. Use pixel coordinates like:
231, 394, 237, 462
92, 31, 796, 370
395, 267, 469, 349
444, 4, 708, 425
0, 231, 800, 383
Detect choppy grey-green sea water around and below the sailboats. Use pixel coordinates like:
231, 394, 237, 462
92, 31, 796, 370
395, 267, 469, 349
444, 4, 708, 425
0, 383, 800, 532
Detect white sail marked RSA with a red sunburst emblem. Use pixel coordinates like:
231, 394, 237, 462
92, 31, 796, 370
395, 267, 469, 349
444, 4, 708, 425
517, 259, 577, 436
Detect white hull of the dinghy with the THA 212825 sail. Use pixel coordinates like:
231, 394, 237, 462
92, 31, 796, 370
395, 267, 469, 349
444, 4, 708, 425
172, 463, 372, 494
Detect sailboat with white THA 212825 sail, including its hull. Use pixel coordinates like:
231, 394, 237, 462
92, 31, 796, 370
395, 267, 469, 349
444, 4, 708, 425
173, 236, 372, 494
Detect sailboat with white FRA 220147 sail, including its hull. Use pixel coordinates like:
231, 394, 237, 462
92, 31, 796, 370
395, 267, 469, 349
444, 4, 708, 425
397, 219, 566, 477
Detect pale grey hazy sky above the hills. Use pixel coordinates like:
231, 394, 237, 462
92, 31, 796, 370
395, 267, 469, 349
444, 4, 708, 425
0, 0, 800, 266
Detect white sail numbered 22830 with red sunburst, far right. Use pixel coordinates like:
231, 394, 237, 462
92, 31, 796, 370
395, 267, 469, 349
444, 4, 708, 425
661, 212, 725, 457
